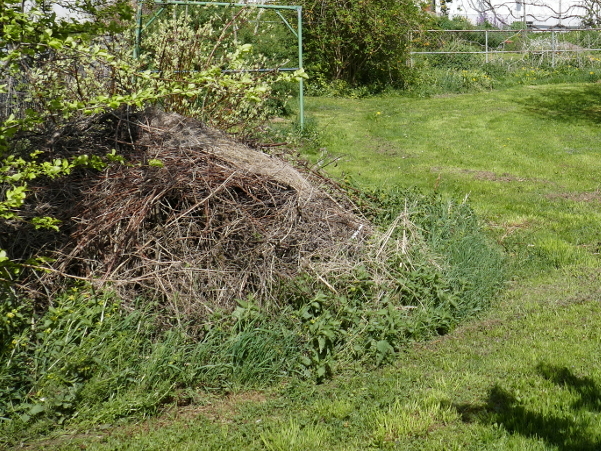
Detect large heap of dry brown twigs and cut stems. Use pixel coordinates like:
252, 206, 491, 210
0, 110, 370, 318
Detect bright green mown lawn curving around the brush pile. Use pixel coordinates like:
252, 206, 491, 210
14, 84, 601, 451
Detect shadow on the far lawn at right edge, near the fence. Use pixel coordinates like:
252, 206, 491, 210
517, 85, 601, 124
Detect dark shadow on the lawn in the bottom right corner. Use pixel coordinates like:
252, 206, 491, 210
455, 364, 601, 451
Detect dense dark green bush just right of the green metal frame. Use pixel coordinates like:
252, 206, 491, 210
299, 0, 426, 87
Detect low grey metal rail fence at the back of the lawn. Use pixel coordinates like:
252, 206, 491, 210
409, 28, 601, 67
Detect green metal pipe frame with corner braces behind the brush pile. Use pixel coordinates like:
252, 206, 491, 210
134, 0, 305, 129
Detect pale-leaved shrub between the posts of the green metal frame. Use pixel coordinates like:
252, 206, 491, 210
137, 9, 304, 132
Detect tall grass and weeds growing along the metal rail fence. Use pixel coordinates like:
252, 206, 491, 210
407, 27, 601, 96
